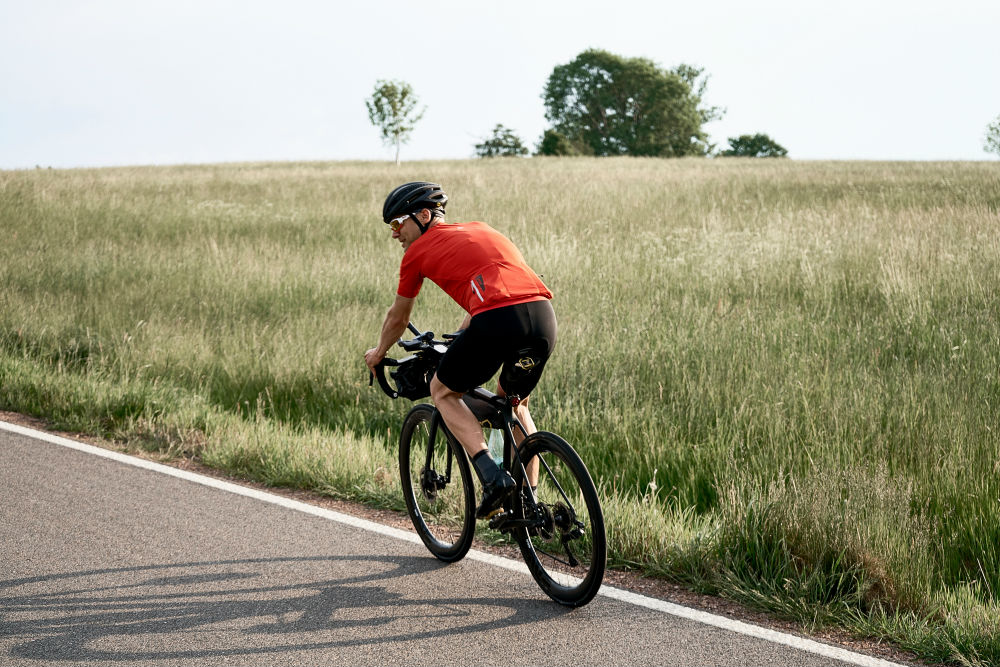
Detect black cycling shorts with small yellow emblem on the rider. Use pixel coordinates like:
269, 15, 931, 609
437, 300, 556, 399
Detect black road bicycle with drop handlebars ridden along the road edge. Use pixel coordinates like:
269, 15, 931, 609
369, 323, 607, 607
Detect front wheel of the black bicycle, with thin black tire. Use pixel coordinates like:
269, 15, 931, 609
399, 403, 476, 563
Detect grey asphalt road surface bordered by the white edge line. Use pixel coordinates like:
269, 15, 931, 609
0, 430, 908, 666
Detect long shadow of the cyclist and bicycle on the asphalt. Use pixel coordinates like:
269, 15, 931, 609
0, 556, 580, 662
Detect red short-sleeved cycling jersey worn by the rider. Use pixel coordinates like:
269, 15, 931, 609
397, 222, 552, 315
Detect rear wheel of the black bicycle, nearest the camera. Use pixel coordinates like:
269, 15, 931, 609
514, 431, 607, 607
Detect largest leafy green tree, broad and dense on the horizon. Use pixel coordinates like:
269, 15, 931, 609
542, 49, 722, 157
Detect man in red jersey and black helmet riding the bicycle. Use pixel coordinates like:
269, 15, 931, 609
365, 181, 556, 518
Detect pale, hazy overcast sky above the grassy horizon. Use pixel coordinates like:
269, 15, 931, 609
0, 0, 1000, 169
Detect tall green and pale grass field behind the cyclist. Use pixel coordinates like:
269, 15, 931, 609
0, 158, 1000, 665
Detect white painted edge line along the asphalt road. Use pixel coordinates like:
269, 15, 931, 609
0, 421, 902, 667
